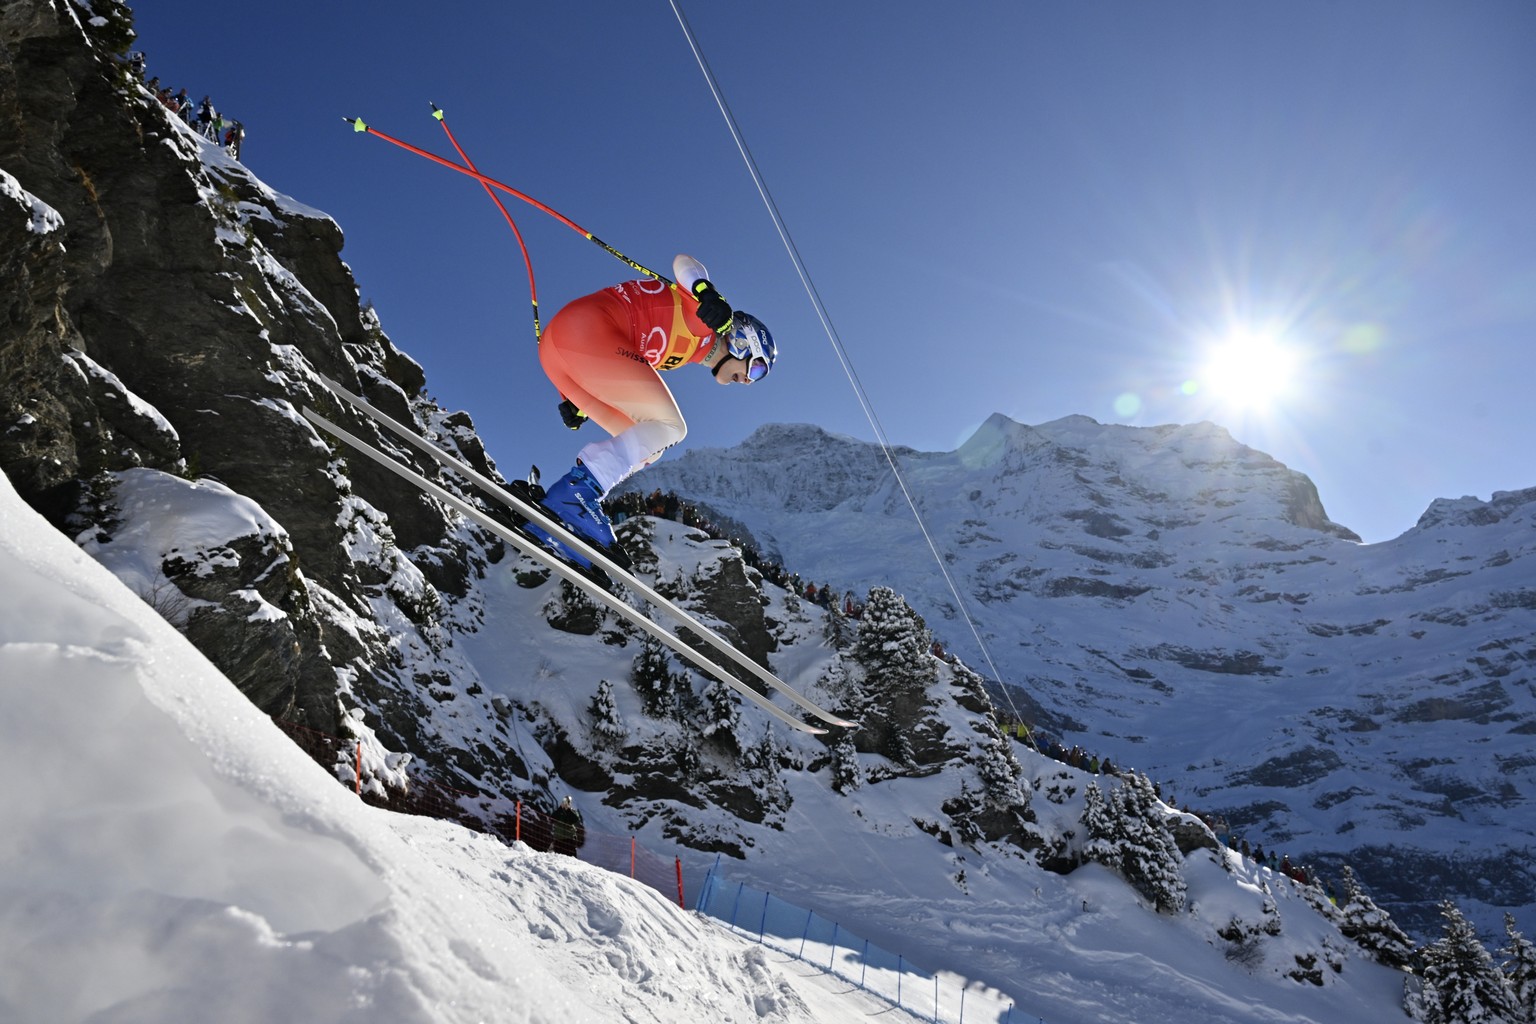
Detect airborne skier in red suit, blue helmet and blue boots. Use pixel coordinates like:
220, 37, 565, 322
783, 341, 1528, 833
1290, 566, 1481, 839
530, 255, 779, 565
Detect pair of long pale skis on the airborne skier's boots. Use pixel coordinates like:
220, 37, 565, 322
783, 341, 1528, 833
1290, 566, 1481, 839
304, 375, 854, 732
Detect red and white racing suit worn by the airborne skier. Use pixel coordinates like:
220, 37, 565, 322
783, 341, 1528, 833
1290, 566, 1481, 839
539, 256, 716, 493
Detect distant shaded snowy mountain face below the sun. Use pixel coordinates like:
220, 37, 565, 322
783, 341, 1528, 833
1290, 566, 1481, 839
633, 415, 1536, 933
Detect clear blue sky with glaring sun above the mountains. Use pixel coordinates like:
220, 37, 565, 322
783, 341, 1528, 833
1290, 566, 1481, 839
135, 0, 1536, 542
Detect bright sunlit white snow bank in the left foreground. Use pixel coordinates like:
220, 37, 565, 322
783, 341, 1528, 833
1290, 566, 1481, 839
0, 477, 909, 1024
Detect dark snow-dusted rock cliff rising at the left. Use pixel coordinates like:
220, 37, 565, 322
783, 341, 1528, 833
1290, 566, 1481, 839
0, 2, 465, 749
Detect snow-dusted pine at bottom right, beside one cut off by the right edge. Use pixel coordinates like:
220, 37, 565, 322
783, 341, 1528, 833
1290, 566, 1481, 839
1416, 900, 1524, 1024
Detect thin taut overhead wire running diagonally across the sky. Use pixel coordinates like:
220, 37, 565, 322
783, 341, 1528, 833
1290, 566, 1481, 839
668, 0, 1038, 749
